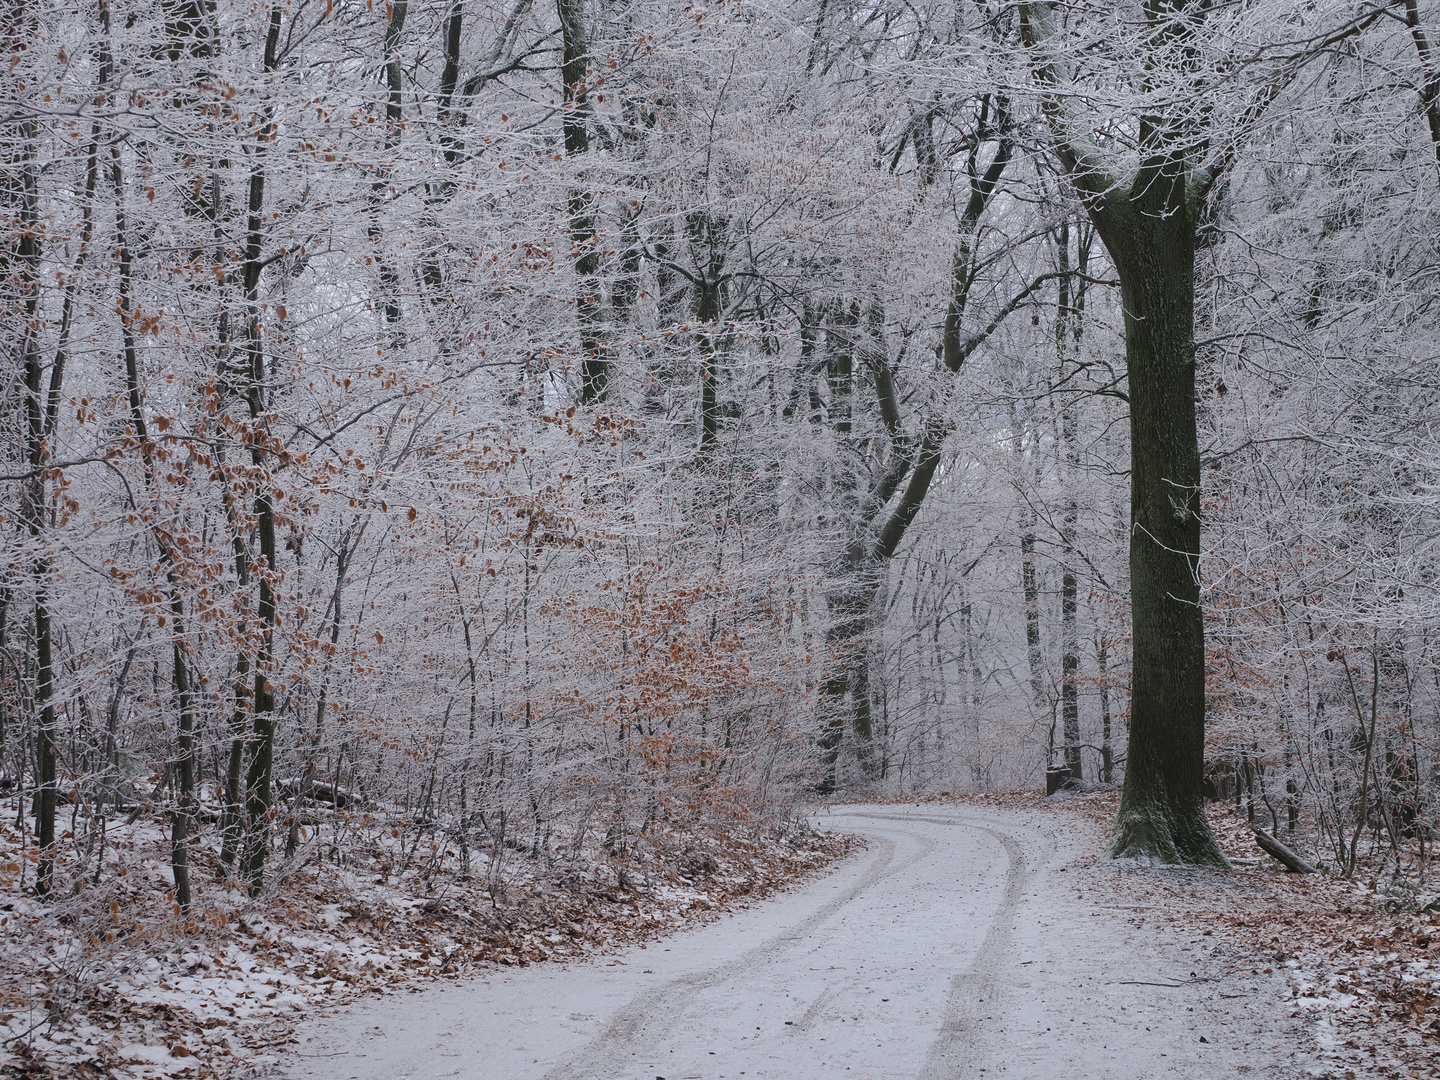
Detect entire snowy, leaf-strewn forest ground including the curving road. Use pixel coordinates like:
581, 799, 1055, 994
0, 793, 1440, 1080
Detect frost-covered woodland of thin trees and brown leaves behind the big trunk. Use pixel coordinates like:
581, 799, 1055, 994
0, 0, 1440, 904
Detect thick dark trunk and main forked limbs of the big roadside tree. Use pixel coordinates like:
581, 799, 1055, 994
1021, 0, 1225, 865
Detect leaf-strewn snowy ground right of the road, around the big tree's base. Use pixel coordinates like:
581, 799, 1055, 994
924, 792, 1440, 1080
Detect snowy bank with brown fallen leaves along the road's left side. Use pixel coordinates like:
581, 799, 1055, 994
0, 804, 854, 1080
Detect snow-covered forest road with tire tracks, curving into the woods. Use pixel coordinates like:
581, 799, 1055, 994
282, 806, 1305, 1080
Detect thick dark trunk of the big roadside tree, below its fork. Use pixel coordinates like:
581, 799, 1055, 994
1093, 194, 1225, 865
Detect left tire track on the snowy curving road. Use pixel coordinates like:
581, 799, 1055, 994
544, 815, 936, 1080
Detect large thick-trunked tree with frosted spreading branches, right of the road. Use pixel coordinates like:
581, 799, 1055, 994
1021, 0, 1380, 865
